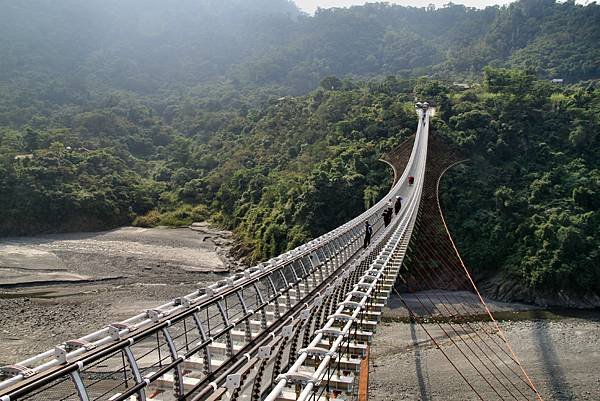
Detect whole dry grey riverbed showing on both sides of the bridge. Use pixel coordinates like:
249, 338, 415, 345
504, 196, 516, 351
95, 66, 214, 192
0, 225, 600, 401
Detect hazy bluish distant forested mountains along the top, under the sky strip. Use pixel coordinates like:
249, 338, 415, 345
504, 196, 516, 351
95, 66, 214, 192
0, 0, 600, 97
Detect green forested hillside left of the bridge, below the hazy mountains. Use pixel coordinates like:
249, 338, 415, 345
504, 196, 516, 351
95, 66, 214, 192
0, 78, 416, 258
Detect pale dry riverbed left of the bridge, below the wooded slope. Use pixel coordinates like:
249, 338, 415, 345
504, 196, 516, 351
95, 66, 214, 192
0, 224, 245, 365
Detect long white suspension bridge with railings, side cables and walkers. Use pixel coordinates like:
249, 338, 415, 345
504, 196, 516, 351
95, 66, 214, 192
0, 108, 542, 401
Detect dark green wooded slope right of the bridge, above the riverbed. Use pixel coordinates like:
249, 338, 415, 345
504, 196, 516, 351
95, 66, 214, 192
436, 69, 600, 295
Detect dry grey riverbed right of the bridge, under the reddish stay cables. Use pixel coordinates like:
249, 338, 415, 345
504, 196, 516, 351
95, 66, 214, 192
369, 294, 600, 401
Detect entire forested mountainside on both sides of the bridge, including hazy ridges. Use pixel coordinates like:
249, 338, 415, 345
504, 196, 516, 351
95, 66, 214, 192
0, 0, 600, 291
